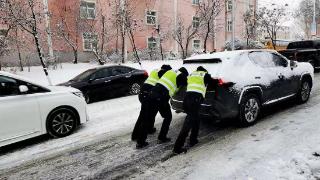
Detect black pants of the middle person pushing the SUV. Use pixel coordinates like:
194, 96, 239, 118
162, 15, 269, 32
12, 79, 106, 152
137, 88, 172, 143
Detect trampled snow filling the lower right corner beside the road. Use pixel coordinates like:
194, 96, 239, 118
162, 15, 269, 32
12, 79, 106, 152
138, 79, 320, 180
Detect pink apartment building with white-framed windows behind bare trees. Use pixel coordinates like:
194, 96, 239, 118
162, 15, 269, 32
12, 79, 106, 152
0, 0, 257, 64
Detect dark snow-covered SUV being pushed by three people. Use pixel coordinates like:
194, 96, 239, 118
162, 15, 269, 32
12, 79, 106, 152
171, 50, 314, 125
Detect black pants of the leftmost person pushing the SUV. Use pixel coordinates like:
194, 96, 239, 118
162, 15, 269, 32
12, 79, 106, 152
131, 92, 153, 140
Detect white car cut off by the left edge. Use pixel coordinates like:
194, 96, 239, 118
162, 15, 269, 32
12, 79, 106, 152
0, 71, 88, 147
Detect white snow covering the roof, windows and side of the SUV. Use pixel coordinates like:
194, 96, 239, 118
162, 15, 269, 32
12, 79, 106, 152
185, 50, 313, 93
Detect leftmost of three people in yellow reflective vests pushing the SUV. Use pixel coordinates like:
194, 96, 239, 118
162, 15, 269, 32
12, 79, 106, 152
131, 64, 172, 141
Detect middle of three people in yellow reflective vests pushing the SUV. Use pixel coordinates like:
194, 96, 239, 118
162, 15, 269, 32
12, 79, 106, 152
136, 67, 189, 149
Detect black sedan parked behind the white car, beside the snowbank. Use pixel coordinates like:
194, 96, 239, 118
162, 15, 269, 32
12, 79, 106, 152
59, 66, 148, 103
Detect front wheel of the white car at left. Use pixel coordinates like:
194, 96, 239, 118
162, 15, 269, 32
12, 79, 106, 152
46, 108, 77, 137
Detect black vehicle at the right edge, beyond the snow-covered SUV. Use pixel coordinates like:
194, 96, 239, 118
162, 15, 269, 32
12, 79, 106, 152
279, 40, 320, 70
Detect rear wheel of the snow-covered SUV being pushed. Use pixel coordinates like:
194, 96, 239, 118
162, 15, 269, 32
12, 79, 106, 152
239, 94, 261, 126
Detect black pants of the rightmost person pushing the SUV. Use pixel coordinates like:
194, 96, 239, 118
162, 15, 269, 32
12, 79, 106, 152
174, 92, 203, 151
